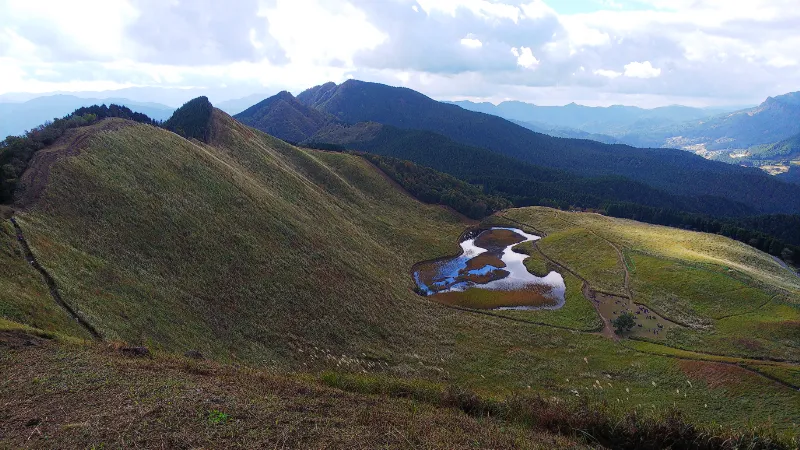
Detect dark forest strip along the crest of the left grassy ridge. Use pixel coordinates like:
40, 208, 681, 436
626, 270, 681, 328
0, 105, 158, 204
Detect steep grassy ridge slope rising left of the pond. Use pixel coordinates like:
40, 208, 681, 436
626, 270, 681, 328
10, 112, 464, 360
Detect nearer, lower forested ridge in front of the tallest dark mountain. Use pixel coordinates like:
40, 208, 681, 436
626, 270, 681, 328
235, 93, 758, 216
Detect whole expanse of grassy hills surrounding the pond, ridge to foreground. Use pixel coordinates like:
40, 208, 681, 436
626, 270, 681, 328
0, 98, 800, 448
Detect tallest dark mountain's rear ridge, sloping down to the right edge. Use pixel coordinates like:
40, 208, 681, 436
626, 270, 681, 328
290, 80, 800, 213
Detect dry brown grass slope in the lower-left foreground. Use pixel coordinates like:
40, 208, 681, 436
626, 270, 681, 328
0, 333, 572, 449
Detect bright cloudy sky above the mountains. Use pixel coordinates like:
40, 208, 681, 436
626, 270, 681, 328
0, 0, 800, 107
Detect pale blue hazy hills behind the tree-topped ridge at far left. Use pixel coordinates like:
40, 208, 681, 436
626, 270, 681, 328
0, 95, 175, 139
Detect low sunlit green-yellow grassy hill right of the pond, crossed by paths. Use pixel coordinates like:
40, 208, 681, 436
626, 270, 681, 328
501, 208, 800, 362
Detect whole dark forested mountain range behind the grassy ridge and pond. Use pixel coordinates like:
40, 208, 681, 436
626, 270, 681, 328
236, 80, 800, 215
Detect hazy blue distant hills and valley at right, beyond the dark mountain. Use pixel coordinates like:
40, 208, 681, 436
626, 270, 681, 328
453, 92, 800, 163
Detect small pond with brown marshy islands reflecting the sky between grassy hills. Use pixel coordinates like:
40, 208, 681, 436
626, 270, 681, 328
413, 227, 566, 310
